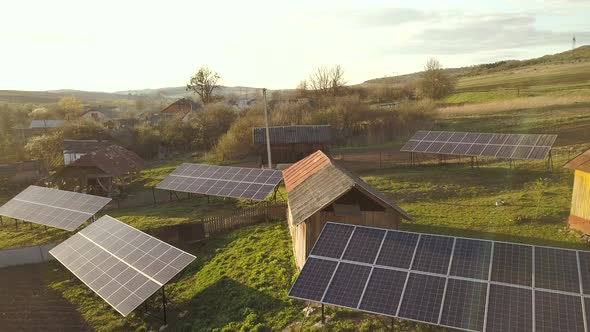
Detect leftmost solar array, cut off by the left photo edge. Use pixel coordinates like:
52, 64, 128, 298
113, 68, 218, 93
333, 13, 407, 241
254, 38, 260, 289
0, 186, 111, 231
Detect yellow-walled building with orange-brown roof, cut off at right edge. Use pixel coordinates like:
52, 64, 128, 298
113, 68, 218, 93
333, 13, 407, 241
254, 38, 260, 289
564, 150, 590, 234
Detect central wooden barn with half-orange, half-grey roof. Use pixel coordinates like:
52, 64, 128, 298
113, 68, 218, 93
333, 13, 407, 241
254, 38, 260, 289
283, 151, 412, 268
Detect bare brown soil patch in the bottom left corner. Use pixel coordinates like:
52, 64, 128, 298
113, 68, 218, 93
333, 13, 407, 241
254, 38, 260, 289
0, 264, 91, 332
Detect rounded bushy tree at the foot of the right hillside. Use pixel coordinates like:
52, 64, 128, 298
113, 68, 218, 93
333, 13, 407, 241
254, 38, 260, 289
419, 58, 455, 99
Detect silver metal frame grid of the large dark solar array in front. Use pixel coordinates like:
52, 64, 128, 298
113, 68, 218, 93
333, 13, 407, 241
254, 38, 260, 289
288, 222, 590, 332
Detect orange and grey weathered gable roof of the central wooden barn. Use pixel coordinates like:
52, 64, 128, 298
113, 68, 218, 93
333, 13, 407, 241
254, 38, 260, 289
283, 151, 412, 224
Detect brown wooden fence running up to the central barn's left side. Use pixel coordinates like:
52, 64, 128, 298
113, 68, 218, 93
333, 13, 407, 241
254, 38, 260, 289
202, 202, 287, 236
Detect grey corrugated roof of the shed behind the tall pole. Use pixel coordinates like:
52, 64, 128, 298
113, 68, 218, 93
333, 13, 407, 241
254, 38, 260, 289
252, 125, 332, 144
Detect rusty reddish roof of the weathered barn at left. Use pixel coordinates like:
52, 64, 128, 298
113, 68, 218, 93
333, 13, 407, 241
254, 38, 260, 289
66, 145, 143, 176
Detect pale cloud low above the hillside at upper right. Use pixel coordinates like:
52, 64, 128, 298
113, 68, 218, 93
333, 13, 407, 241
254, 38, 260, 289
388, 14, 590, 55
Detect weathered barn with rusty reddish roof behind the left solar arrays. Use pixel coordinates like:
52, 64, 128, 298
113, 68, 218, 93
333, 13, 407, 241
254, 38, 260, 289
54, 145, 143, 196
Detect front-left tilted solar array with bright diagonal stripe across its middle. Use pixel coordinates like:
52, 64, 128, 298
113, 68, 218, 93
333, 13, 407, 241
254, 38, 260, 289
49, 216, 195, 316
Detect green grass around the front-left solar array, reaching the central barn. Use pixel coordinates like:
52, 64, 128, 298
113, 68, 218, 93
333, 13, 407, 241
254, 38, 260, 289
48, 222, 303, 331
